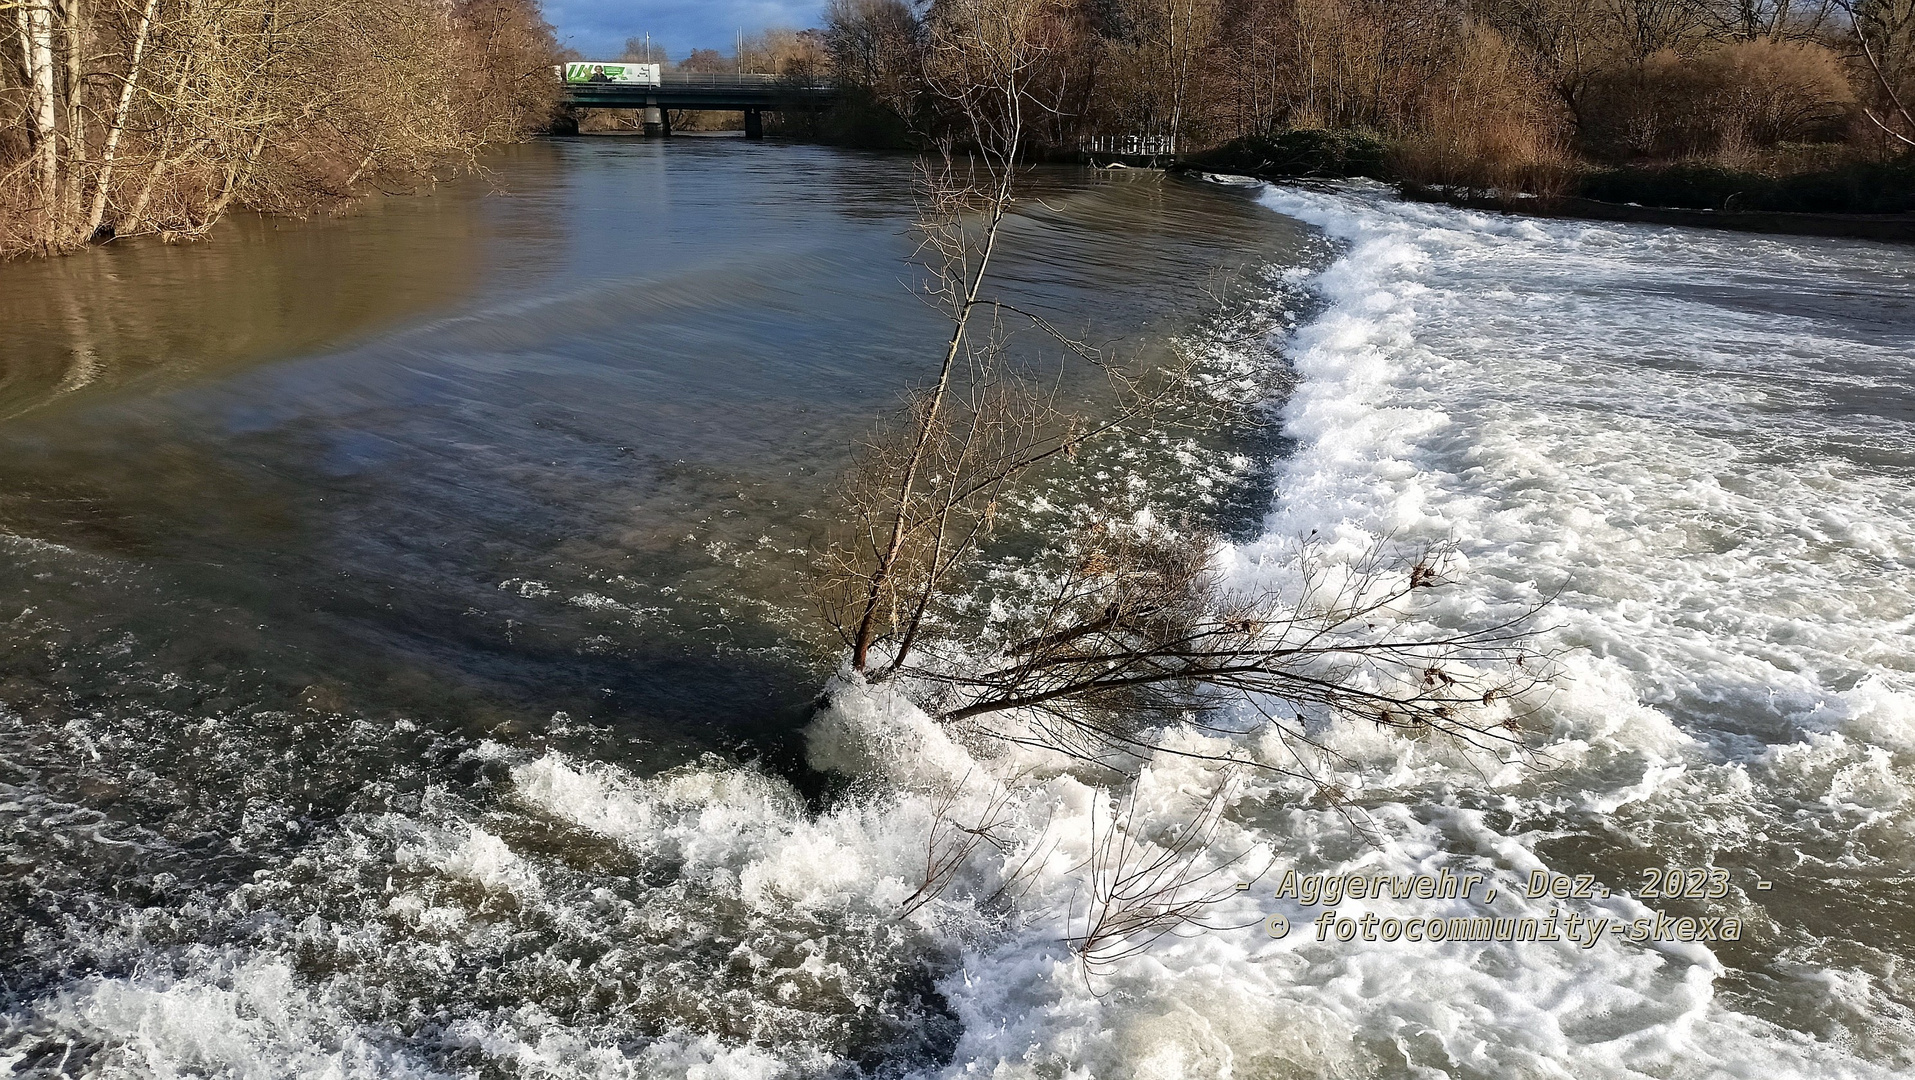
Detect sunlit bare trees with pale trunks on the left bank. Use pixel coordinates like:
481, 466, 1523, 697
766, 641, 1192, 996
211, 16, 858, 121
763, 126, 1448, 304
0, 0, 559, 255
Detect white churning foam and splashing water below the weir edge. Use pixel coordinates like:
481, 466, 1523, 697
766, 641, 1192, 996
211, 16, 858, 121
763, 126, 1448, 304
0, 164, 1915, 1080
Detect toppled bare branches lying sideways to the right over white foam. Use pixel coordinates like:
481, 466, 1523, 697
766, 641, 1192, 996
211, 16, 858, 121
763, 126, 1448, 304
904, 523, 1549, 779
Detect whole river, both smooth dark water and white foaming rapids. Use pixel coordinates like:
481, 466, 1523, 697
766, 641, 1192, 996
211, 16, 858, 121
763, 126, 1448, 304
0, 138, 1915, 1078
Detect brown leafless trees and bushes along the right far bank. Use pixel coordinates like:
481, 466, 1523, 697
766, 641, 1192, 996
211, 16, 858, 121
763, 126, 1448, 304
822, 0, 1915, 186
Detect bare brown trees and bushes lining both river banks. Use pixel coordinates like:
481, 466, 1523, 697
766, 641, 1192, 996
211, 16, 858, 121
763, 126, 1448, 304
11, 0, 1915, 255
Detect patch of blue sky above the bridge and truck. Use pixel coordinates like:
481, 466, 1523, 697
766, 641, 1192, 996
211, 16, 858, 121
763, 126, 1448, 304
546, 0, 825, 59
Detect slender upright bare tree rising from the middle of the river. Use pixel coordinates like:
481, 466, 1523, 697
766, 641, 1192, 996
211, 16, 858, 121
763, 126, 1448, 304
825, 0, 1113, 674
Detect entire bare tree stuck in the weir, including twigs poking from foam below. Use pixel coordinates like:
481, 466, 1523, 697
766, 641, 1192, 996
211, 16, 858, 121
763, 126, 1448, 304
812, 0, 1551, 977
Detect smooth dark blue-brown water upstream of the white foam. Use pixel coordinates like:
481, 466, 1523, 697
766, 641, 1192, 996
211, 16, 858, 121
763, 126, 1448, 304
0, 138, 1308, 1067
